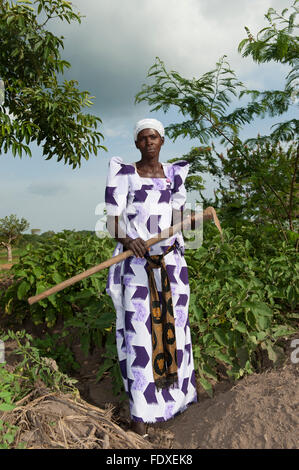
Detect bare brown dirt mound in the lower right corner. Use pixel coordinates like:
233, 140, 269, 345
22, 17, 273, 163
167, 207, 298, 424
158, 346, 299, 449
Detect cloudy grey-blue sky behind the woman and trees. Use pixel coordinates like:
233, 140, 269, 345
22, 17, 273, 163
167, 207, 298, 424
0, 0, 291, 232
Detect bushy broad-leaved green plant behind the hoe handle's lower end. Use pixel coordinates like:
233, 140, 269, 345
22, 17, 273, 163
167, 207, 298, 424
0, 230, 113, 327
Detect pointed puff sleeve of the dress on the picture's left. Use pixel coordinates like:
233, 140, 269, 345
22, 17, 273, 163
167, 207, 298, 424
105, 157, 128, 216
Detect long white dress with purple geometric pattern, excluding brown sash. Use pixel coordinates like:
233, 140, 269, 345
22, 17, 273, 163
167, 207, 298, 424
105, 157, 197, 423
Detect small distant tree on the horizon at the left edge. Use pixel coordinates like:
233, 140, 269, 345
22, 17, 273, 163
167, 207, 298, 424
0, 214, 29, 263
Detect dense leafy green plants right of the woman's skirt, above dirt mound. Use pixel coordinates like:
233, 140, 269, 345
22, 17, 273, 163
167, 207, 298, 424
186, 226, 299, 393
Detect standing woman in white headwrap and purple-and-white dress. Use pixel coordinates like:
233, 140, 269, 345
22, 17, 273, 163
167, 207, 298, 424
105, 119, 211, 435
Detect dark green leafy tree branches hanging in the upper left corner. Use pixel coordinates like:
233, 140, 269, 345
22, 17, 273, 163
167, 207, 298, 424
0, 0, 105, 168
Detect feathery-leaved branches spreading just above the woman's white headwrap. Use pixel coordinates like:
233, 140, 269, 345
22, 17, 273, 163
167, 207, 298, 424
136, 56, 248, 144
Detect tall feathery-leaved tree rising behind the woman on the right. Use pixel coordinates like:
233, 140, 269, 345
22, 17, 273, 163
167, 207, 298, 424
136, 0, 299, 238
